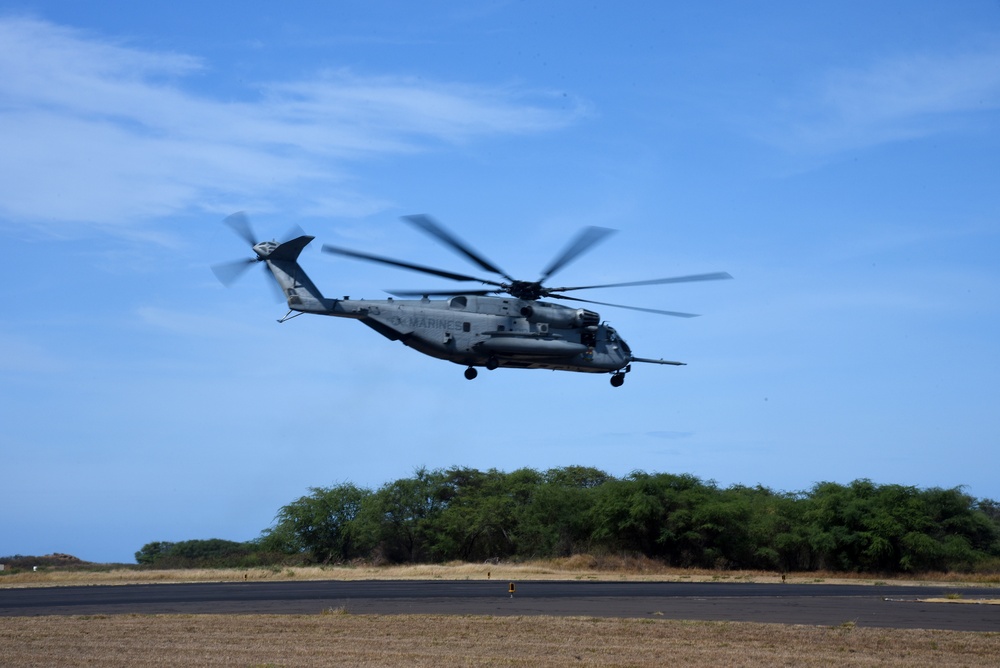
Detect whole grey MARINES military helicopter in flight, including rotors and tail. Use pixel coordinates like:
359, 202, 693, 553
212, 212, 732, 387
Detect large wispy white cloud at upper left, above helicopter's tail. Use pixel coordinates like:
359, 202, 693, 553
0, 17, 583, 230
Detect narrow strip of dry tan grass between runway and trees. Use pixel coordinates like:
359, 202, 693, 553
0, 555, 1000, 589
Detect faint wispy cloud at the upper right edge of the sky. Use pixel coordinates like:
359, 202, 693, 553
771, 46, 1000, 152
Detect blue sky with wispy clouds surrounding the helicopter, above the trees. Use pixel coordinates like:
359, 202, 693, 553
0, 0, 1000, 562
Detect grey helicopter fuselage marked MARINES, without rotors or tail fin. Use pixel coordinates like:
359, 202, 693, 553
308, 295, 631, 373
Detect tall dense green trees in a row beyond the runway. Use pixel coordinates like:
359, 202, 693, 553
136, 466, 1000, 572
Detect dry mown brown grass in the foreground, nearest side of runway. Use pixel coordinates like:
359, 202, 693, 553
0, 610, 1000, 668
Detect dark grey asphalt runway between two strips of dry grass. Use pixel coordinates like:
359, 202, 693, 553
0, 580, 1000, 632
